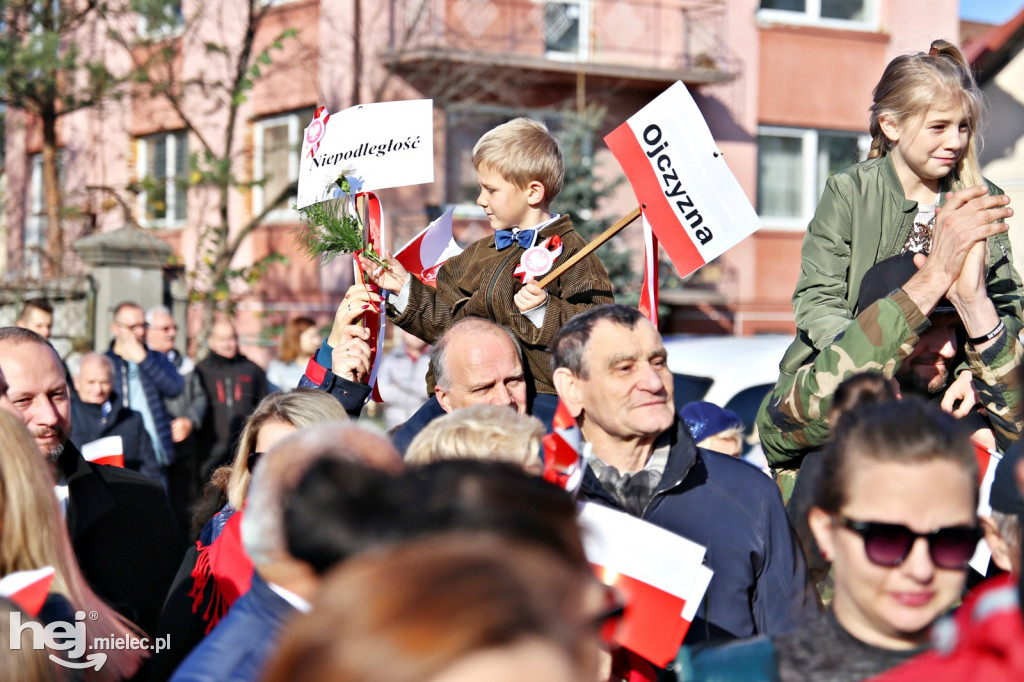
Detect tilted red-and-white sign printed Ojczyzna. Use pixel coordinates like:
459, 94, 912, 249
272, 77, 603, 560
604, 82, 761, 278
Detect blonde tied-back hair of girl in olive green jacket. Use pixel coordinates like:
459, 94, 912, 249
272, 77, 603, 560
867, 40, 985, 189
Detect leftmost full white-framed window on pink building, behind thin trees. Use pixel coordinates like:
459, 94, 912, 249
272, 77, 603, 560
137, 130, 188, 227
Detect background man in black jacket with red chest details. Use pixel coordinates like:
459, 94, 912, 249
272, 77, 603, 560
196, 319, 269, 485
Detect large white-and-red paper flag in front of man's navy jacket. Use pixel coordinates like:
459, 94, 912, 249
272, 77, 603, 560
580, 503, 713, 668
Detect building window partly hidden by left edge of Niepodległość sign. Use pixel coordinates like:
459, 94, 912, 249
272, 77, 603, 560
253, 109, 313, 221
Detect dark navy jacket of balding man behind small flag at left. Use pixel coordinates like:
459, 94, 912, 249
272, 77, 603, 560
71, 393, 163, 482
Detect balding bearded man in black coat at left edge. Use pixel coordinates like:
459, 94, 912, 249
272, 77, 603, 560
0, 327, 182, 633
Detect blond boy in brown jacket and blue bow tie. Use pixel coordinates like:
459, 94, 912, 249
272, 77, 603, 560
360, 119, 612, 409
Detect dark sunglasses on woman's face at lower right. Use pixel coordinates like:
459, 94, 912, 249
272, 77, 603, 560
836, 515, 981, 570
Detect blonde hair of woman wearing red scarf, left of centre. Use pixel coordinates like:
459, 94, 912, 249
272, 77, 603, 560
227, 388, 348, 509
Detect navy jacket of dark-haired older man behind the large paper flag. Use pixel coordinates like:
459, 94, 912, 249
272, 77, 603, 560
581, 418, 818, 643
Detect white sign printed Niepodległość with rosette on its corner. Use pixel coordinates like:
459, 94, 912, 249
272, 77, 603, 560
297, 99, 434, 209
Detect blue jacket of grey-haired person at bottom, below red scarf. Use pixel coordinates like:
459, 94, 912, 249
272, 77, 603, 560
171, 572, 299, 682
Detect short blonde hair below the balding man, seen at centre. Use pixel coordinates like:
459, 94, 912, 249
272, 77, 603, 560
406, 404, 544, 474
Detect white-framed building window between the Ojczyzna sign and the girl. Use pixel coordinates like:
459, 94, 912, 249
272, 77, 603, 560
758, 127, 870, 228
